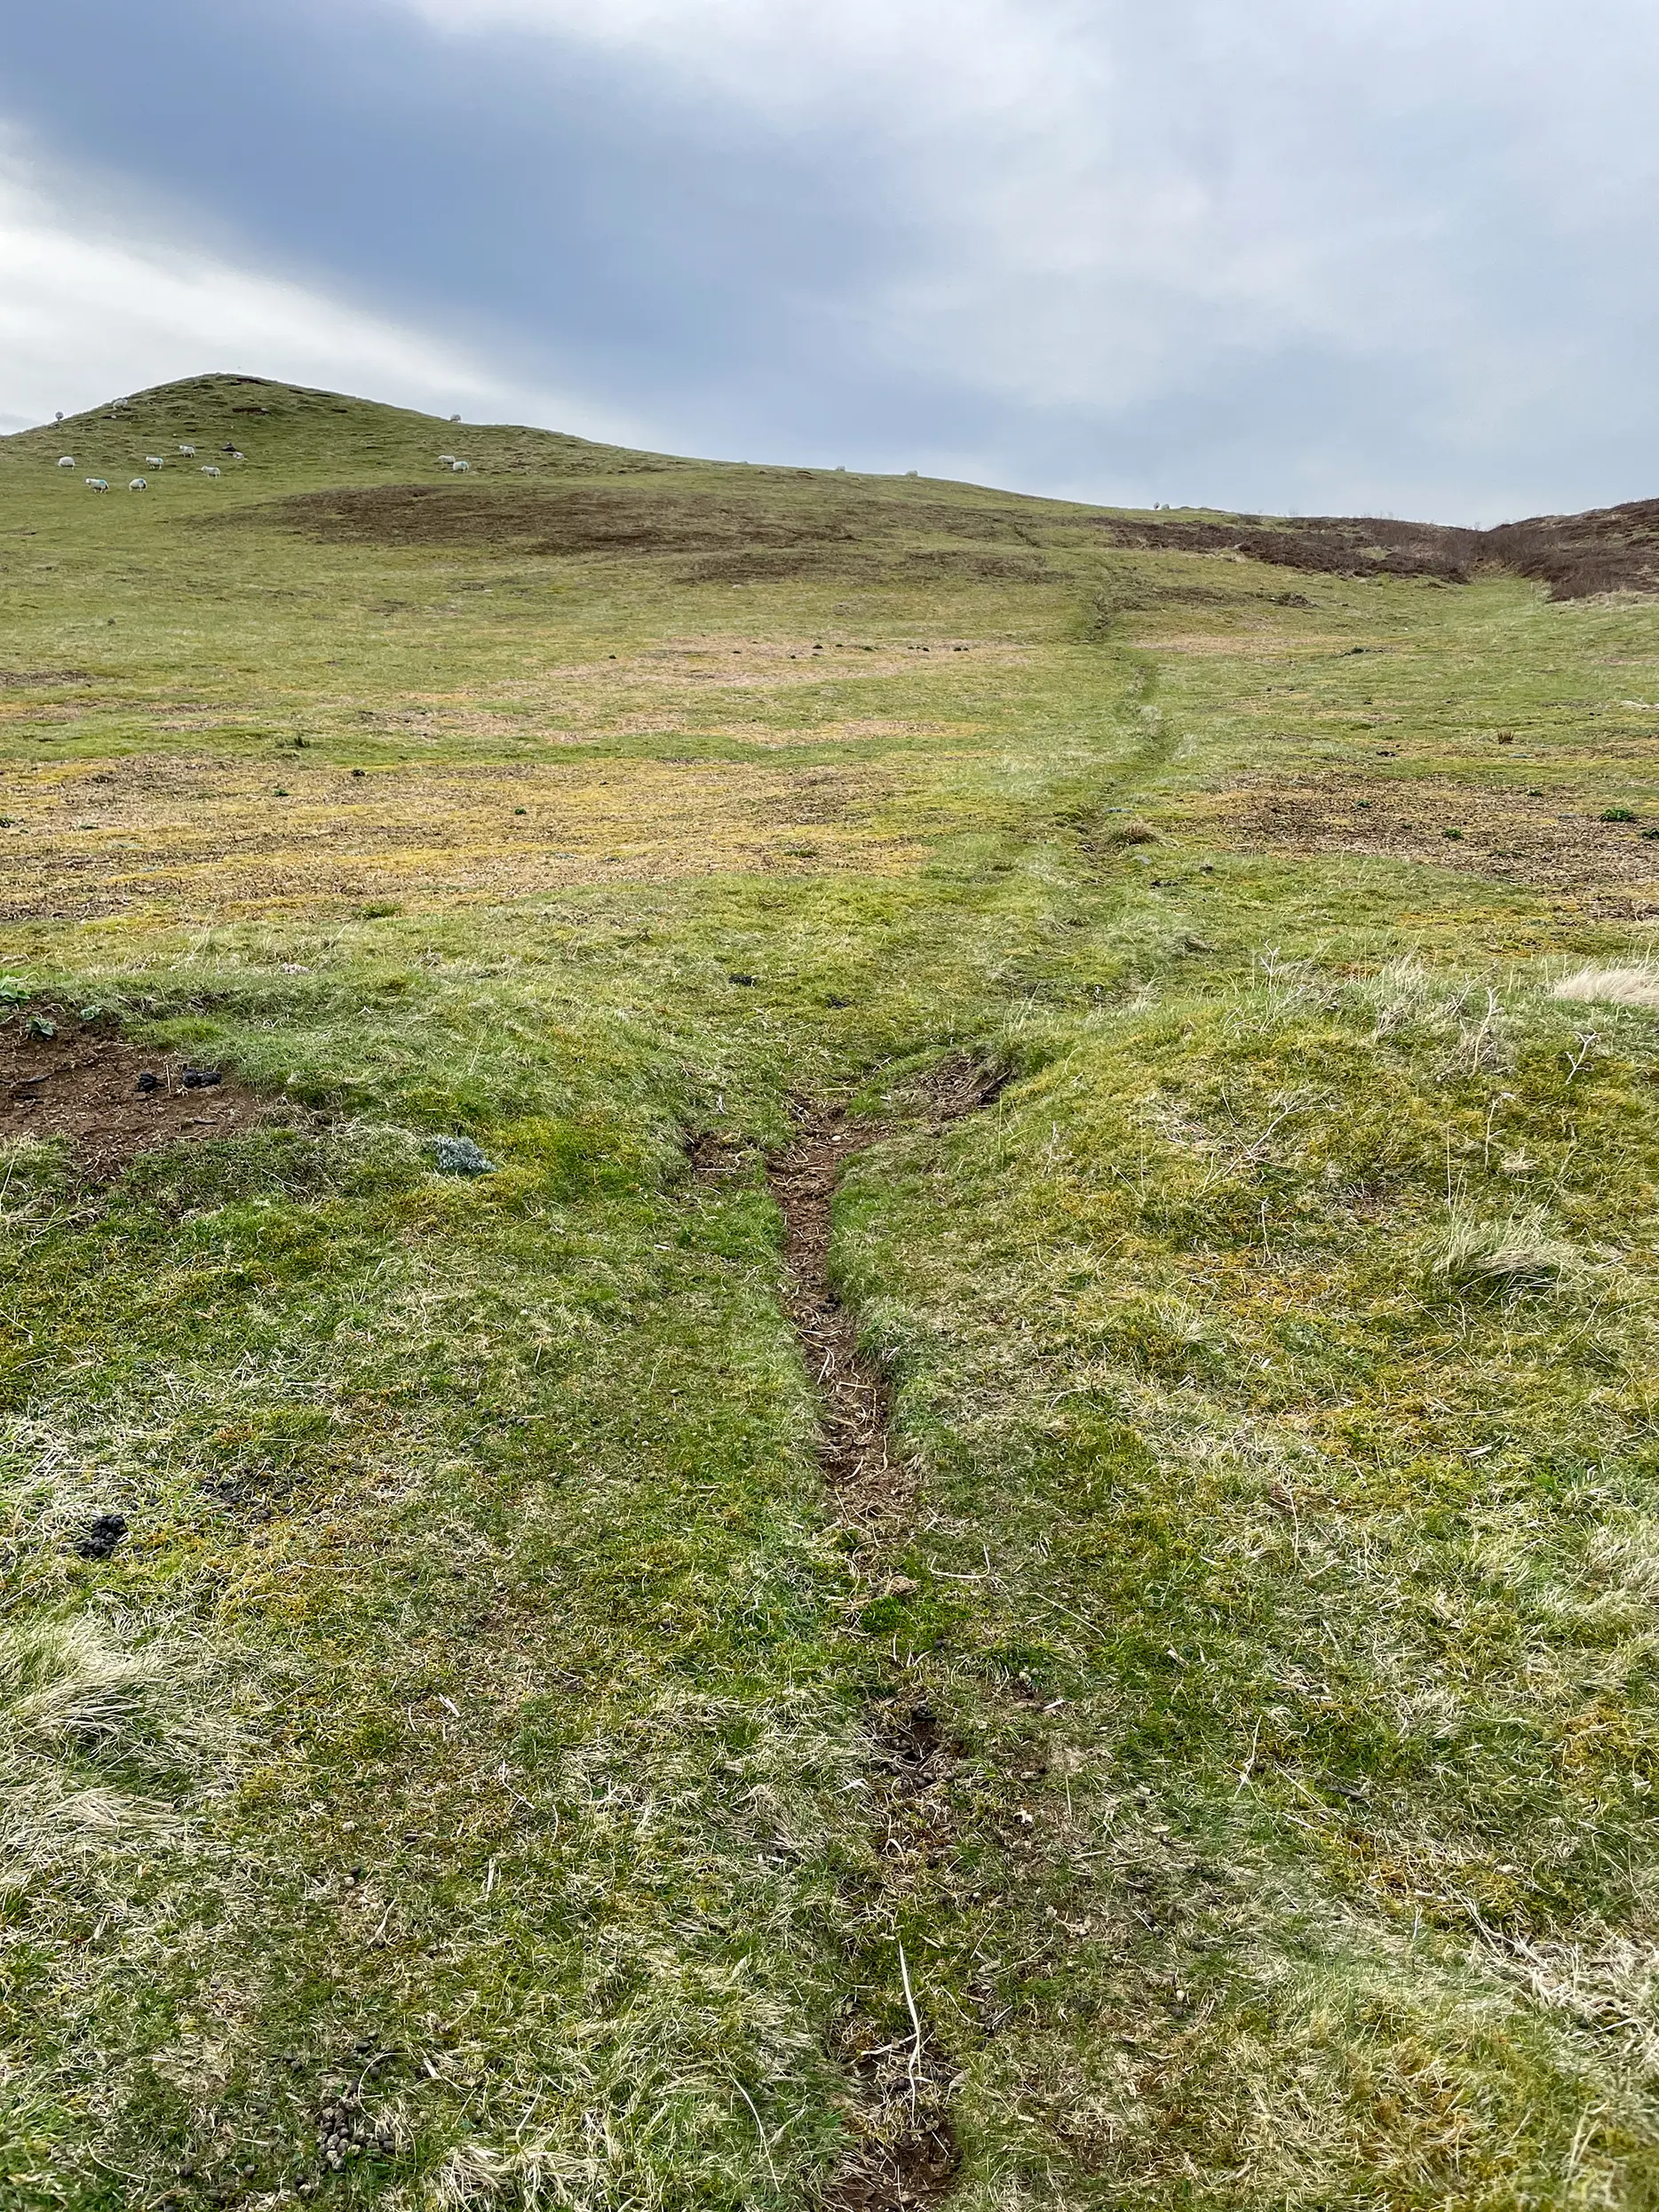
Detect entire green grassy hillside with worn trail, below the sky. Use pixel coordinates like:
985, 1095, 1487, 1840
0, 376, 1659, 2212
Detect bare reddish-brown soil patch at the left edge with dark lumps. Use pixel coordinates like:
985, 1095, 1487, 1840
0, 1007, 270, 1182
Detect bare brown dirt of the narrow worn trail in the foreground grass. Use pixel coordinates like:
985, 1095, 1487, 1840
767, 1055, 1006, 2212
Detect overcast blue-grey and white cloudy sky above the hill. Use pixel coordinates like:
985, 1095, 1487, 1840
0, 0, 1659, 522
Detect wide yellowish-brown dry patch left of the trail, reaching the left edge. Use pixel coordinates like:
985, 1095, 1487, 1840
0, 759, 938, 920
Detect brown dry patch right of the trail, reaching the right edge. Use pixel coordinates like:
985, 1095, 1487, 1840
1217, 776, 1659, 916
